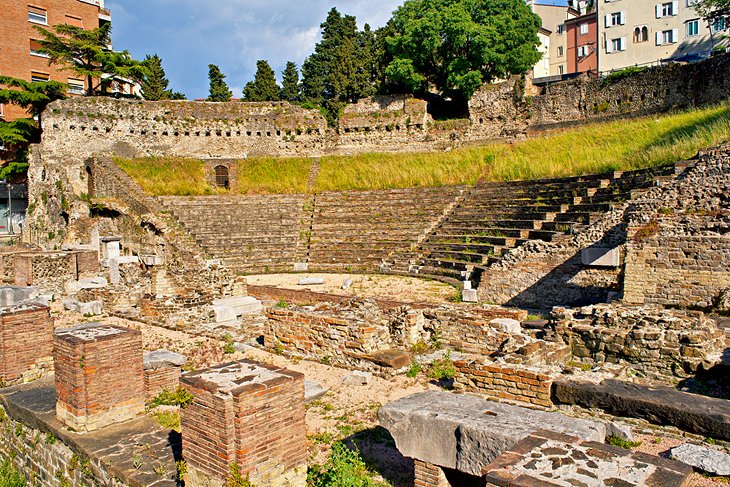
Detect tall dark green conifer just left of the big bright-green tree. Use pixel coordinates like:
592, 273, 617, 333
302, 8, 375, 125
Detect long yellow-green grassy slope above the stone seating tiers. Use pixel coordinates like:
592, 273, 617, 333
116, 104, 730, 195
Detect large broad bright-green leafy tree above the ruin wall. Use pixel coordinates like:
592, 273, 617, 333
385, 0, 541, 101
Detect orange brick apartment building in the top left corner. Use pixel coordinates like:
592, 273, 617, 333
0, 0, 111, 121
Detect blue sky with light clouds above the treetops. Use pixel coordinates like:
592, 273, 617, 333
106, 0, 566, 99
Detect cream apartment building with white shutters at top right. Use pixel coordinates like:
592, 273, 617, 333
597, 0, 729, 72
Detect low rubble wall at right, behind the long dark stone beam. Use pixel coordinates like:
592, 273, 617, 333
552, 305, 725, 377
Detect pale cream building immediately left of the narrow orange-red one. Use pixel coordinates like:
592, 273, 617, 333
527, 0, 578, 78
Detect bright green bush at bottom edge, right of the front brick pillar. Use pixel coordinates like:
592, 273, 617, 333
307, 441, 376, 487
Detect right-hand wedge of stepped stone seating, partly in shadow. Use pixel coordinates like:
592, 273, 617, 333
392, 162, 686, 283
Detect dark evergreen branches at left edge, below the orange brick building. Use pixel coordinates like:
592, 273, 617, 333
0, 76, 67, 179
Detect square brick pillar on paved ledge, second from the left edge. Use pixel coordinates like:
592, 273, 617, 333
53, 323, 144, 431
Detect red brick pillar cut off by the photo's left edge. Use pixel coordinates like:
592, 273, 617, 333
0, 303, 53, 385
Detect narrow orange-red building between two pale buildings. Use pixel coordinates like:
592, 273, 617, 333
565, 12, 598, 74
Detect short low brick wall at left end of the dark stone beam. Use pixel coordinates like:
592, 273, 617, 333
454, 360, 553, 409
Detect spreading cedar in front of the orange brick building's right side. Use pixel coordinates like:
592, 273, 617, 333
36, 24, 147, 95
